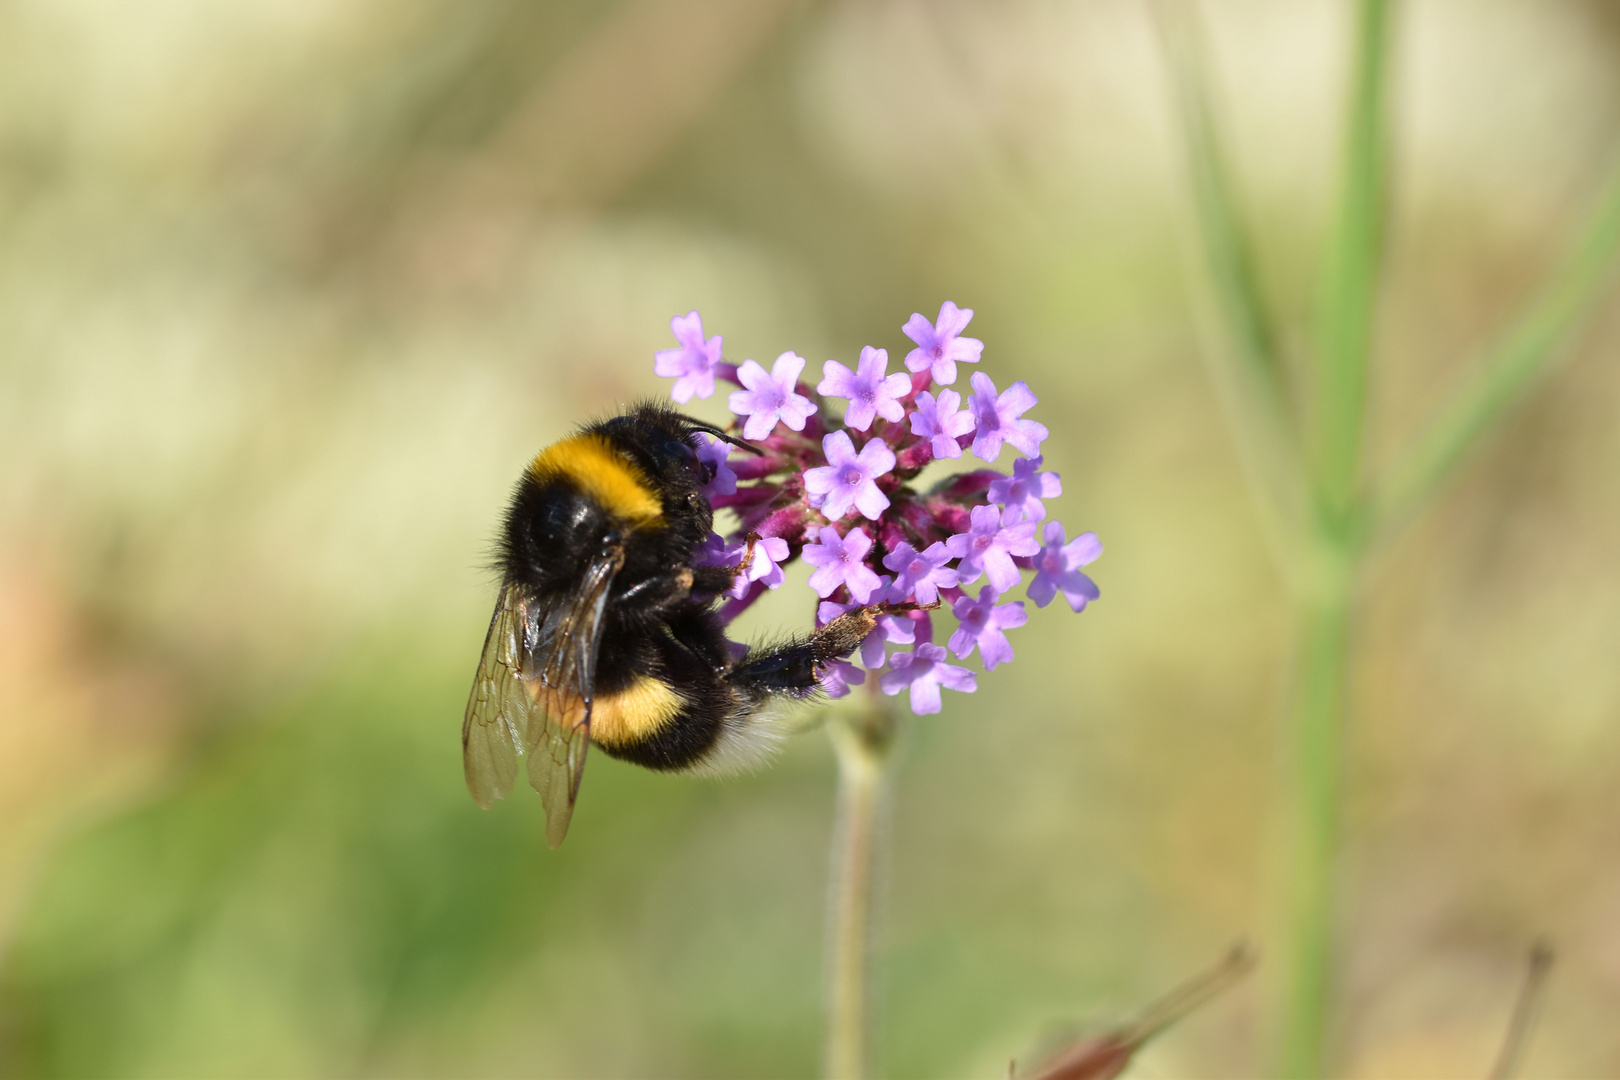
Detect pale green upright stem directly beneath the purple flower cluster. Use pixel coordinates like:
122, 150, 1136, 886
826, 693, 899, 1080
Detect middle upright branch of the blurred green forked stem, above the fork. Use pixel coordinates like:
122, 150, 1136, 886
1312, 0, 1390, 525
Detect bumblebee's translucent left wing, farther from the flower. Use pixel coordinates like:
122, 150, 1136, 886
462, 585, 538, 810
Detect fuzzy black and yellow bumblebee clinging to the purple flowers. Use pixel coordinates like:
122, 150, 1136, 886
462, 403, 885, 847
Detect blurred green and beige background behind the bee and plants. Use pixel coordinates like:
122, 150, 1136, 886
0, 0, 1620, 1077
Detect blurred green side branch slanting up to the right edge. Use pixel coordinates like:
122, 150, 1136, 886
1377, 167, 1620, 533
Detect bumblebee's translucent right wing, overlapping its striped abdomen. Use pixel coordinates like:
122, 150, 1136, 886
520, 549, 624, 847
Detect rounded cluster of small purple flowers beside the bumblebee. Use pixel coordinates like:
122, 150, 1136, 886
654, 301, 1103, 714
